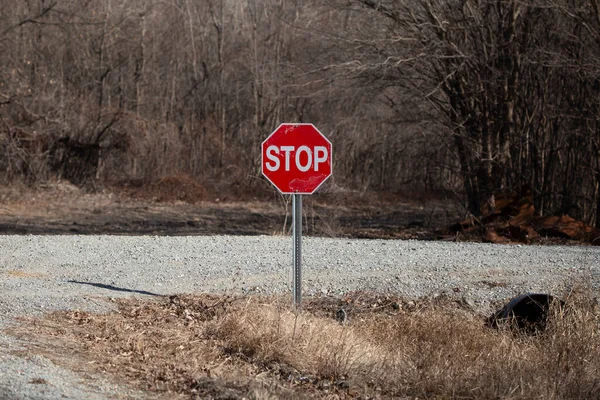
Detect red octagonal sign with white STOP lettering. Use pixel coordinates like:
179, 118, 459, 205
262, 124, 331, 194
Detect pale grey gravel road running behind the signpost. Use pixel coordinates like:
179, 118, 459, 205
0, 236, 600, 399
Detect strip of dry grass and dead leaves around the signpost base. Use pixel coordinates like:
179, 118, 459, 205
8, 293, 600, 399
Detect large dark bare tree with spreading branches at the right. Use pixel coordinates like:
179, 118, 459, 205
338, 0, 598, 223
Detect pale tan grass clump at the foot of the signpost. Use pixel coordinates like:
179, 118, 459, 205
214, 301, 375, 381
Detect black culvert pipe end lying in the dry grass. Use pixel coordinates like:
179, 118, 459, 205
488, 293, 565, 334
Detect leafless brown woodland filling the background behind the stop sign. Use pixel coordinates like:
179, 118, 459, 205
0, 0, 600, 227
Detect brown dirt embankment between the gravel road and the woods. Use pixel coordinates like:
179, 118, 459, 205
0, 180, 600, 245
